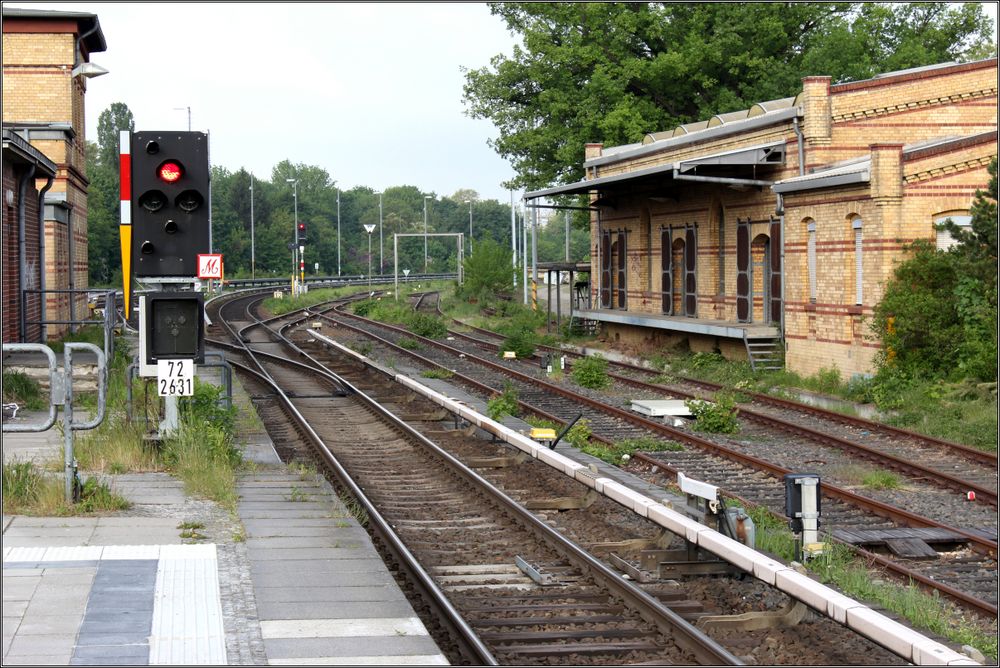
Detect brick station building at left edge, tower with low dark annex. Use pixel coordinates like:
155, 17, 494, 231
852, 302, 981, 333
3, 6, 107, 342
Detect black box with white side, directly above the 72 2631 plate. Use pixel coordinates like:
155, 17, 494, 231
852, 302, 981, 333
139, 292, 205, 375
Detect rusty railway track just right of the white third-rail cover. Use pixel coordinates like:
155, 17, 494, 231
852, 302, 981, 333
306, 294, 996, 617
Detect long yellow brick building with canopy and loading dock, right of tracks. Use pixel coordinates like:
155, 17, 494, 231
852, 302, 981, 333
525, 58, 997, 377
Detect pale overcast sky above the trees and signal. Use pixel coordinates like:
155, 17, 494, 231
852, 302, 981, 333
5, 1, 996, 202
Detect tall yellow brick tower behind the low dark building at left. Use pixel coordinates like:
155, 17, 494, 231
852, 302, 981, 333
3, 6, 107, 340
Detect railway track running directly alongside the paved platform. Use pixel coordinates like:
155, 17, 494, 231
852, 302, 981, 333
213, 297, 741, 665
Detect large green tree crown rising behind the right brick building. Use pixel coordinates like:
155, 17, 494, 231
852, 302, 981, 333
464, 2, 995, 188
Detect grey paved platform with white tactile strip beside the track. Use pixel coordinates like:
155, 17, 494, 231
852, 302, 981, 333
2, 352, 448, 666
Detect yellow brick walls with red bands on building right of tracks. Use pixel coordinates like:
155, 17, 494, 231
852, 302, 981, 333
587, 59, 997, 377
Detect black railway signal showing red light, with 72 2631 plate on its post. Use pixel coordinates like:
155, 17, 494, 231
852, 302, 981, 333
120, 131, 214, 436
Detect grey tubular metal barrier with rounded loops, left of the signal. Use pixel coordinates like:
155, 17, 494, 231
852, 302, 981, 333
3, 342, 108, 503
